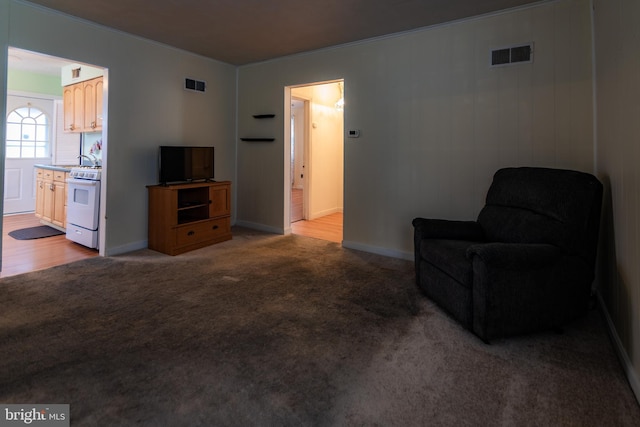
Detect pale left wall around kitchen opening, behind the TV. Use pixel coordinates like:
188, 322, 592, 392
0, 0, 236, 255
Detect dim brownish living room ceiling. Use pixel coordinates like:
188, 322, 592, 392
22, 0, 540, 65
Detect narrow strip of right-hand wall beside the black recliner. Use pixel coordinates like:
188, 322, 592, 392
594, 0, 640, 399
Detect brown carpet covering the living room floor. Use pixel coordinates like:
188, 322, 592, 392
0, 229, 640, 426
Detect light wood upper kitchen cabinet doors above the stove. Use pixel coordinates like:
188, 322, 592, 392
62, 77, 104, 132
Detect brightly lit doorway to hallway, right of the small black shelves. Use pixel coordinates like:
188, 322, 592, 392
285, 80, 344, 243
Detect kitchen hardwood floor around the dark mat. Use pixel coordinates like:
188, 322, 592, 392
0, 214, 98, 277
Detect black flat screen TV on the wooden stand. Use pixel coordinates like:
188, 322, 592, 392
158, 145, 214, 185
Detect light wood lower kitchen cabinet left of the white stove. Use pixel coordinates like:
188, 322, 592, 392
35, 168, 69, 229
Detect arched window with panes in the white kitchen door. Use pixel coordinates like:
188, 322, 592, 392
6, 104, 50, 159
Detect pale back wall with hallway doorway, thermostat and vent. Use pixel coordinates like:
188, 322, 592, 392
238, 0, 594, 258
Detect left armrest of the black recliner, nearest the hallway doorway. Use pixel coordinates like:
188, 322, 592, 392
412, 218, 484, 242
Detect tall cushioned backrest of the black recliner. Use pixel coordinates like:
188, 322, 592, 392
478, 167, 602, 265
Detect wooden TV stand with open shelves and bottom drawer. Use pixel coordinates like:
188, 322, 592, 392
147, 181, 232, 255
